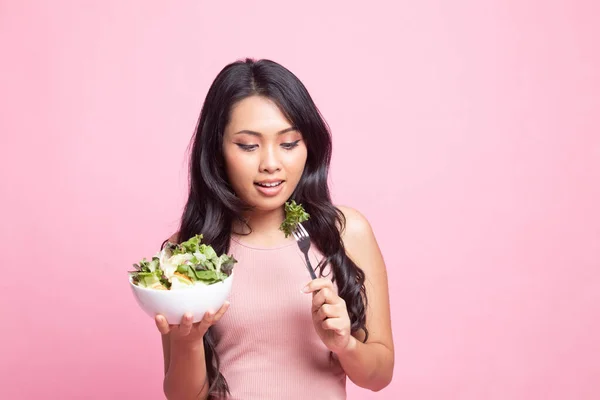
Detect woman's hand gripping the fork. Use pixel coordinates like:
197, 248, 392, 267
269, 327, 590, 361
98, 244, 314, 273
303, 278, 353, 354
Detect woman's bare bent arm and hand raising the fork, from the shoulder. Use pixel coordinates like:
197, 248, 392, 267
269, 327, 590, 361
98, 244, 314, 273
304, 207, 394, 391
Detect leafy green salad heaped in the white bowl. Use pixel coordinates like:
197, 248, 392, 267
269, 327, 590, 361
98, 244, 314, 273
128, 235, 237, 290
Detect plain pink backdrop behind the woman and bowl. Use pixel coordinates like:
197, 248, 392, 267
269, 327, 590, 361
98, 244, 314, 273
0, 0, 600, 400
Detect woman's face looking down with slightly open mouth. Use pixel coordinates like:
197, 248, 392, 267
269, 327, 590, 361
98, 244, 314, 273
223, 96, 307, 211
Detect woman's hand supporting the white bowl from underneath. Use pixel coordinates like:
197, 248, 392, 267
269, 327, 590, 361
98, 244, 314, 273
154, 301, 229, 342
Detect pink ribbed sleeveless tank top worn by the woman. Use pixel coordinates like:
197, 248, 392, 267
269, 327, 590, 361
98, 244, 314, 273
214, 239, 346, 400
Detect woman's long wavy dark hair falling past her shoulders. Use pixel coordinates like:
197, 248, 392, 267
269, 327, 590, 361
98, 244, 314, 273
169, 59, 368, 398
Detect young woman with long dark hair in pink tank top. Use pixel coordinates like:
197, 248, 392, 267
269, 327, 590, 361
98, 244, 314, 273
156, 59, 394, 400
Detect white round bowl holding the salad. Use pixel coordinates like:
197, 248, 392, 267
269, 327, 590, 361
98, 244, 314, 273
129, 272, 234, 324
